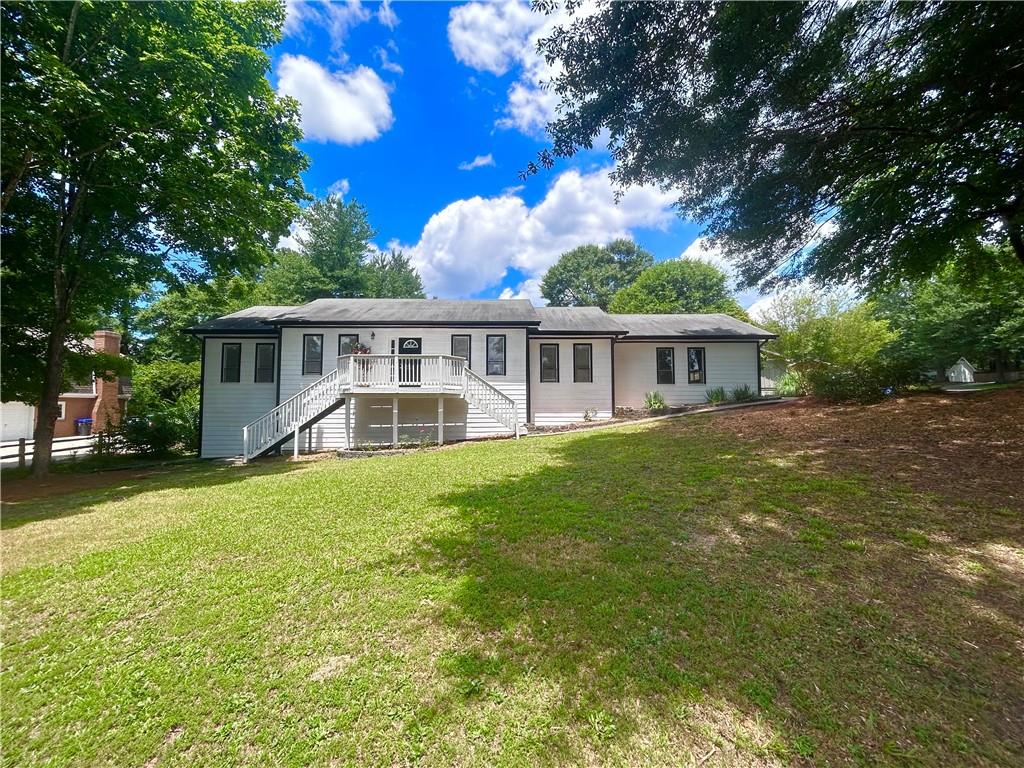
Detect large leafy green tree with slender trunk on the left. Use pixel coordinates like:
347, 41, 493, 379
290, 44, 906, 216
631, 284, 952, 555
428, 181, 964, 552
0, 0, 306, 474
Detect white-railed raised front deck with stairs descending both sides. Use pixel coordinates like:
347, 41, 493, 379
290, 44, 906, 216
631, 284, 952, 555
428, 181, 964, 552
242, 354, 520, 461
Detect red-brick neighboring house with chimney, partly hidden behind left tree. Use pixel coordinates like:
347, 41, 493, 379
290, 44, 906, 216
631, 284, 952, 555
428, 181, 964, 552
0, 331, 131, 440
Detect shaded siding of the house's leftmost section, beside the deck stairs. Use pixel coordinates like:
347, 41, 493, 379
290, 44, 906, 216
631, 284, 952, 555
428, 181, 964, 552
200, 336, 278, 459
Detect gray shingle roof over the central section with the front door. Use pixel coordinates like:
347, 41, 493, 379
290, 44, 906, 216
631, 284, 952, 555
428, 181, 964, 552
264, 299, 541, 326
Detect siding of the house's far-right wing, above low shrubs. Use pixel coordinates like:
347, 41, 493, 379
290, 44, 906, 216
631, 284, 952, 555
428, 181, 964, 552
614, 341, 758, 408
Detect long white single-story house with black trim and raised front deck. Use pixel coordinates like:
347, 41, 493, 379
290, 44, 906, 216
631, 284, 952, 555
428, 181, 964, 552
189, 299, 774, 458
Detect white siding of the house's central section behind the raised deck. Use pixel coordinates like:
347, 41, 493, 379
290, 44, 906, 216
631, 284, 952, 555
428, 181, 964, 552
281, 327, 526, 451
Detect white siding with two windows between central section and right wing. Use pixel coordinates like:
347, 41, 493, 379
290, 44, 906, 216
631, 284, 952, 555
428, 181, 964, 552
529, 338, 612, 426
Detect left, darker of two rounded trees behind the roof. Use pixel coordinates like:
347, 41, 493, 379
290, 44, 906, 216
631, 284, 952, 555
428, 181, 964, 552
541, 240, 654, 309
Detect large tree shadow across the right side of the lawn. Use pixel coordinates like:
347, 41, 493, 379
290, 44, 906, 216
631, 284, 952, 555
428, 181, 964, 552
403, 420, 1024, 765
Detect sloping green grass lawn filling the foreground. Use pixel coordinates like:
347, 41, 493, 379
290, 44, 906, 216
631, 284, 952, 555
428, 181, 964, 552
0, 417, 1024, 766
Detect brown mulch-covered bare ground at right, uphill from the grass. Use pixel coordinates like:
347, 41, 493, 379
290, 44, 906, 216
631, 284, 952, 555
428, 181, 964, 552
710, 387, 1024, 510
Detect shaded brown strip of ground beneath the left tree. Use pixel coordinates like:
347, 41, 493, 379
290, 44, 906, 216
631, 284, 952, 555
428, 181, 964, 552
0, 459, 309, 529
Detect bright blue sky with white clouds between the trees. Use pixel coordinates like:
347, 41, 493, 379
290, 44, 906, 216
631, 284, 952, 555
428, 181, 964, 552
270, 0, 758, 305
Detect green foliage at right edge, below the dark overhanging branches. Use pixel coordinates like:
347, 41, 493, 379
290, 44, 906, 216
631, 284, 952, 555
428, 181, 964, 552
874, 248, 1024, 374
